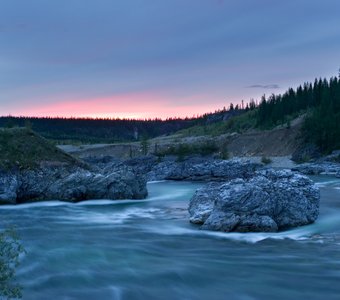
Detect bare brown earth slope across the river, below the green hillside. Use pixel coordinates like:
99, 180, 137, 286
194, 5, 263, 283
59, 118, 303, 163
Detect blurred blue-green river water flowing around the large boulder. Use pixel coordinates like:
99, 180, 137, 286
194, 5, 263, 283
0, 177, 340, 300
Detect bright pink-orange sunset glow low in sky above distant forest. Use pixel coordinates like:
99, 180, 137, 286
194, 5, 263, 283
11, 93, 230, 119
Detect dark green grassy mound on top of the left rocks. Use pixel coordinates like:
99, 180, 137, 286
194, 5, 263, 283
0, 128, 79, 169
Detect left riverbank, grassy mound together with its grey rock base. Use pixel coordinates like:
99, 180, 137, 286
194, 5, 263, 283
0, 128, 147, 204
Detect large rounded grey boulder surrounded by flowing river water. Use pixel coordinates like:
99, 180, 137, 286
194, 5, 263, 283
189, 169, 320, 232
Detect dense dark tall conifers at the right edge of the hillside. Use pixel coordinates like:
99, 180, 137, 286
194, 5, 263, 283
256, 75, 340, 152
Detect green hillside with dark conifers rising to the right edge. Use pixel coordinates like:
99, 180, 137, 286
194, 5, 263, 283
179, 77, 340, 154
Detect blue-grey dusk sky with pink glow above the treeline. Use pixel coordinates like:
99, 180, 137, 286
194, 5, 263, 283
0, 0, 340, 118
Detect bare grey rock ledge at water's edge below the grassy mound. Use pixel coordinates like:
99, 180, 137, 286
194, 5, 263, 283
0, 166, 147, 204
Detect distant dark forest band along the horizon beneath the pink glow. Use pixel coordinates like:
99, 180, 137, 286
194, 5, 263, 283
0, 116, 202, 143
